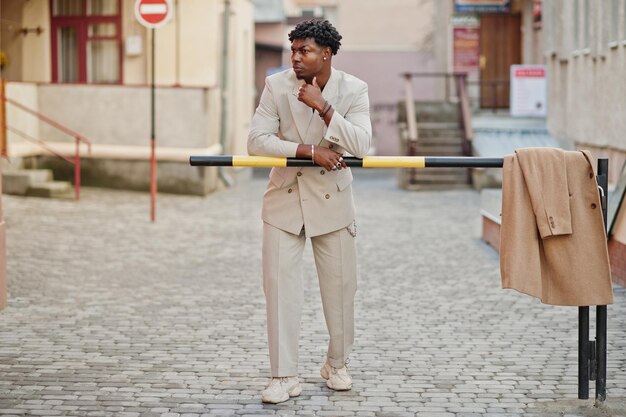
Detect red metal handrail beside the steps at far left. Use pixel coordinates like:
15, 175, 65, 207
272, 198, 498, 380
0, 96, 91, 201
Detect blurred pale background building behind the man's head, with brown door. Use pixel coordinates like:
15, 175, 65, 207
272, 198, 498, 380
255, 0, 543, 155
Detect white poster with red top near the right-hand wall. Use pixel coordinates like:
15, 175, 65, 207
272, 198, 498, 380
511, 65, 548, 117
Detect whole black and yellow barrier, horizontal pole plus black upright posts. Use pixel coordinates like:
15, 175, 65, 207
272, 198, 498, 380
189, 155, 609, 403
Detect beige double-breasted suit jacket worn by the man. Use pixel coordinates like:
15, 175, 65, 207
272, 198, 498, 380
248, 68, 372, 237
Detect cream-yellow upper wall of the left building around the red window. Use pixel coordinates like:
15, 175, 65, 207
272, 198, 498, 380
3, 0, 254, 157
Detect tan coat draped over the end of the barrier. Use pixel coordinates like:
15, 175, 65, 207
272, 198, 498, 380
500, 148, 613, 306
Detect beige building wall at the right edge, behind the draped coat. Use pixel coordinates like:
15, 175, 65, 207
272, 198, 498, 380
543, 0, 626, 285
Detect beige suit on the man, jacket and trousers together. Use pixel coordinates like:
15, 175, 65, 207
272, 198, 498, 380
248, 68, 372, 377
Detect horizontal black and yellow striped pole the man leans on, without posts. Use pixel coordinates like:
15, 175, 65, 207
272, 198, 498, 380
189, 155, 502, 168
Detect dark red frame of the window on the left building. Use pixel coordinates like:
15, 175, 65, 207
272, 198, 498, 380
50, 0, 123, 84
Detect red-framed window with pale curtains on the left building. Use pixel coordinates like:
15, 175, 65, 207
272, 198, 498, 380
51, 0, 122, 84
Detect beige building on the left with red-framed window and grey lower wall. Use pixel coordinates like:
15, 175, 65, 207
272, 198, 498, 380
0, 0, 254, 195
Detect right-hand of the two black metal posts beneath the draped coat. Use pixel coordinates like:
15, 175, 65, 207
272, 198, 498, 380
596, 159, 609, 402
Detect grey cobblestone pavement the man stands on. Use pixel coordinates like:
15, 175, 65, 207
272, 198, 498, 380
0, 171, 626, 417
